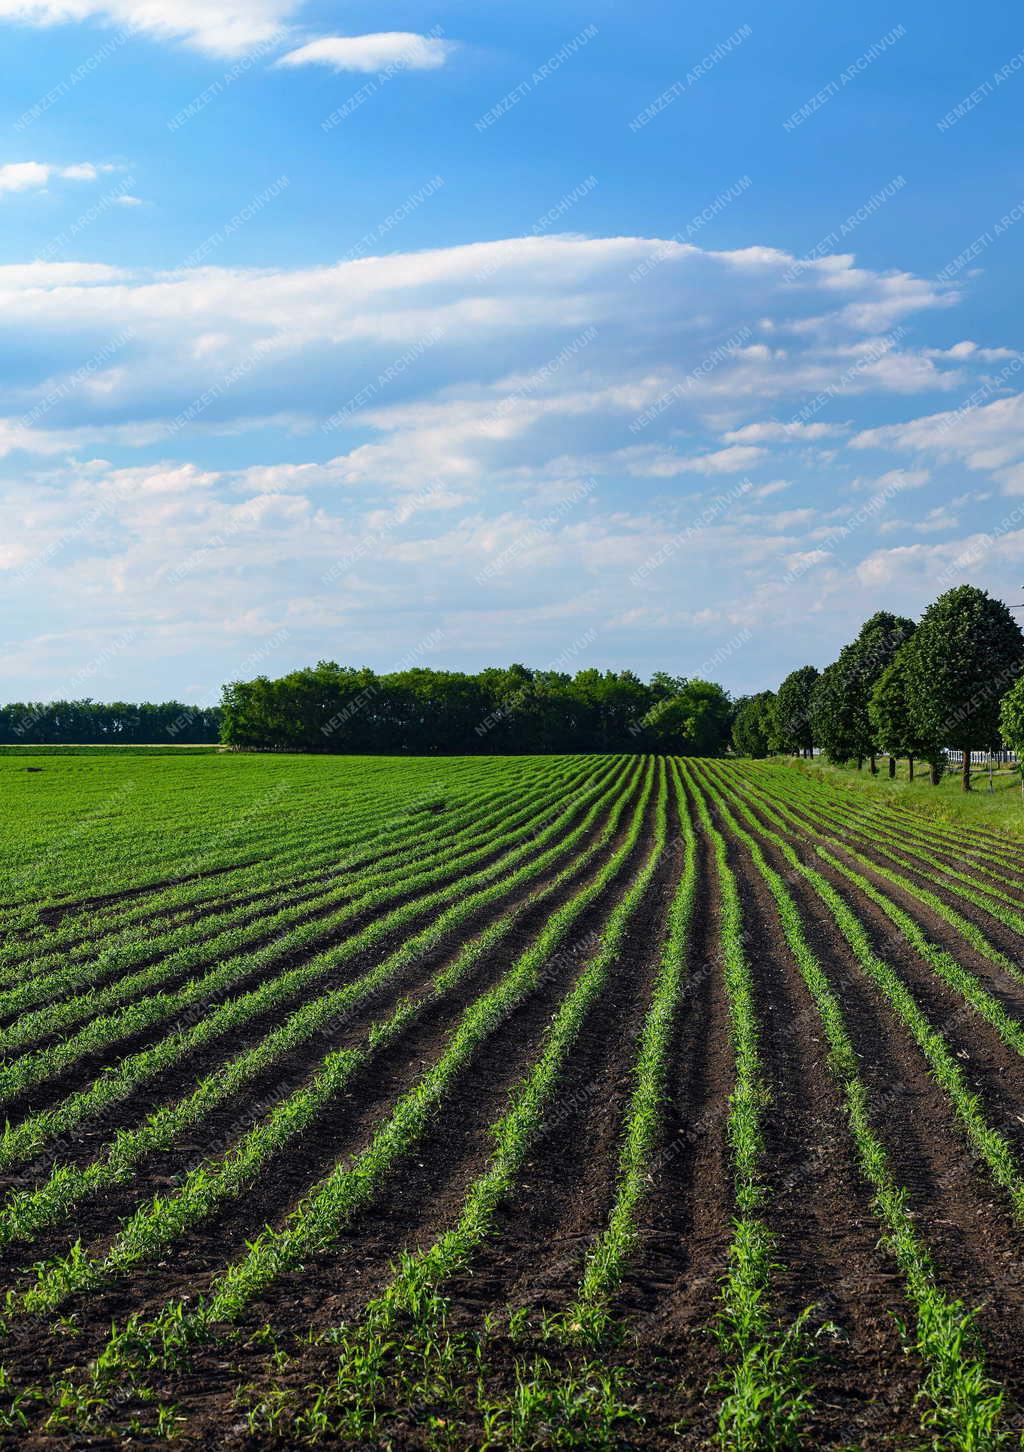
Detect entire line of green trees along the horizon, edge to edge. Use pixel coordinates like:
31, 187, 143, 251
9, 585, 1024, 772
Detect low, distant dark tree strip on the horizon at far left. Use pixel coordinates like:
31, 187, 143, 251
0, 698, 221, 746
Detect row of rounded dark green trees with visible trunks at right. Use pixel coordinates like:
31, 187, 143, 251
732, 585, 1024, 791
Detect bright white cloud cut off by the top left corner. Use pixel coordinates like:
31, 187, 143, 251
0, 0, 296, 55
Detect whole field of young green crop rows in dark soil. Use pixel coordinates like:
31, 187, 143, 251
0, 752, 1024, 1452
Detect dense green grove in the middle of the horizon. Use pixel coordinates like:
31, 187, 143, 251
221, 661, 734, 756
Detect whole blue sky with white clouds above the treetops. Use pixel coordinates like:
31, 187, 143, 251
0, 0, 1024, 700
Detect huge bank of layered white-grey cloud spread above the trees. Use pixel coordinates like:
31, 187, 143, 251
0, 235, 1024, 690
